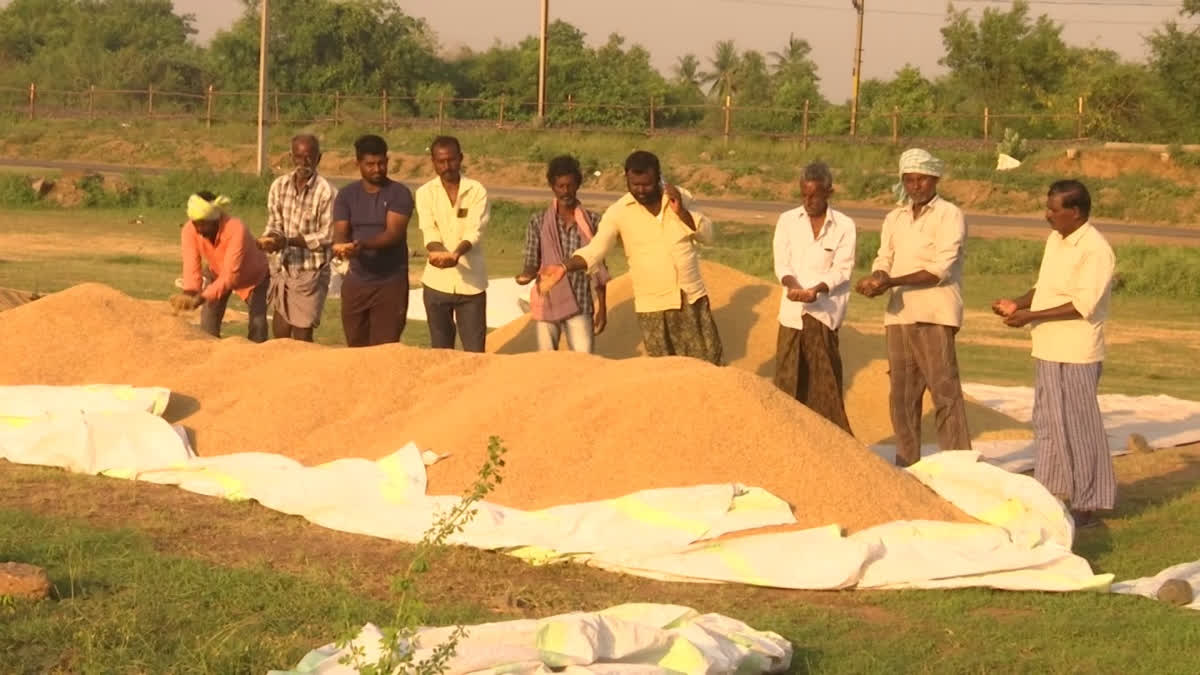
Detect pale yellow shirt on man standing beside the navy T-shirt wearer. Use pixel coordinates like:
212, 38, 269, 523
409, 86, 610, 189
416, 175, 492, 295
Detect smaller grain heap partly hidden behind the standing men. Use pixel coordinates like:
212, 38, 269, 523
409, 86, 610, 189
487, 262, 1032, 444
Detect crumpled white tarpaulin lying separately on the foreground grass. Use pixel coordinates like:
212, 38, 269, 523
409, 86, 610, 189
269, 604, 792, 675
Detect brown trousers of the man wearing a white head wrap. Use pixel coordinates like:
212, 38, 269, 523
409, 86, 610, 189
887, 323, 971, 466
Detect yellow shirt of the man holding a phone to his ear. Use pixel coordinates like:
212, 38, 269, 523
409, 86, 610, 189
575, 190, 713, 313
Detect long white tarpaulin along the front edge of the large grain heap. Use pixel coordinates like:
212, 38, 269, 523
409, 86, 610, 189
0, 388, 1111, 591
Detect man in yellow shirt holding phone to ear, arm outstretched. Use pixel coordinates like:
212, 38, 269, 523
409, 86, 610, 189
538, 150, 722, 365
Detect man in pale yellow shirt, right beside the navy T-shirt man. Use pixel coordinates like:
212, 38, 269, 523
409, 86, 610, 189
416, 136, 492, 352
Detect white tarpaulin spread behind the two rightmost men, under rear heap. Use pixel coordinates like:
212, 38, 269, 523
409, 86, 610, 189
871, 383, 1200, 472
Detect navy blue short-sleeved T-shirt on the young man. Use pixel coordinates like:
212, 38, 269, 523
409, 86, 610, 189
334, 180, 414, 282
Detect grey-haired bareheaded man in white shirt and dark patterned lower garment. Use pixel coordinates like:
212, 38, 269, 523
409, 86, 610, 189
774, 162, 858, 434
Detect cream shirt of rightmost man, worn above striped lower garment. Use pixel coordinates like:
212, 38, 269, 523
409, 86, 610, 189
1030, 223, 1116, 363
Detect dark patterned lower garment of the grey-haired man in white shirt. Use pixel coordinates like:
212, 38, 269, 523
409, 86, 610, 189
775, 315, 851, 434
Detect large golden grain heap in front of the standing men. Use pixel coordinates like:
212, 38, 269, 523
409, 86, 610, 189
0, 285, 966, 530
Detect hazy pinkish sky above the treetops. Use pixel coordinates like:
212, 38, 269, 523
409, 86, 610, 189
175, 0, 1180, 100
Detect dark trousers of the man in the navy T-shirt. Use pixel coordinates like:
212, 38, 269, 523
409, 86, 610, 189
342, 274, 408, 347
